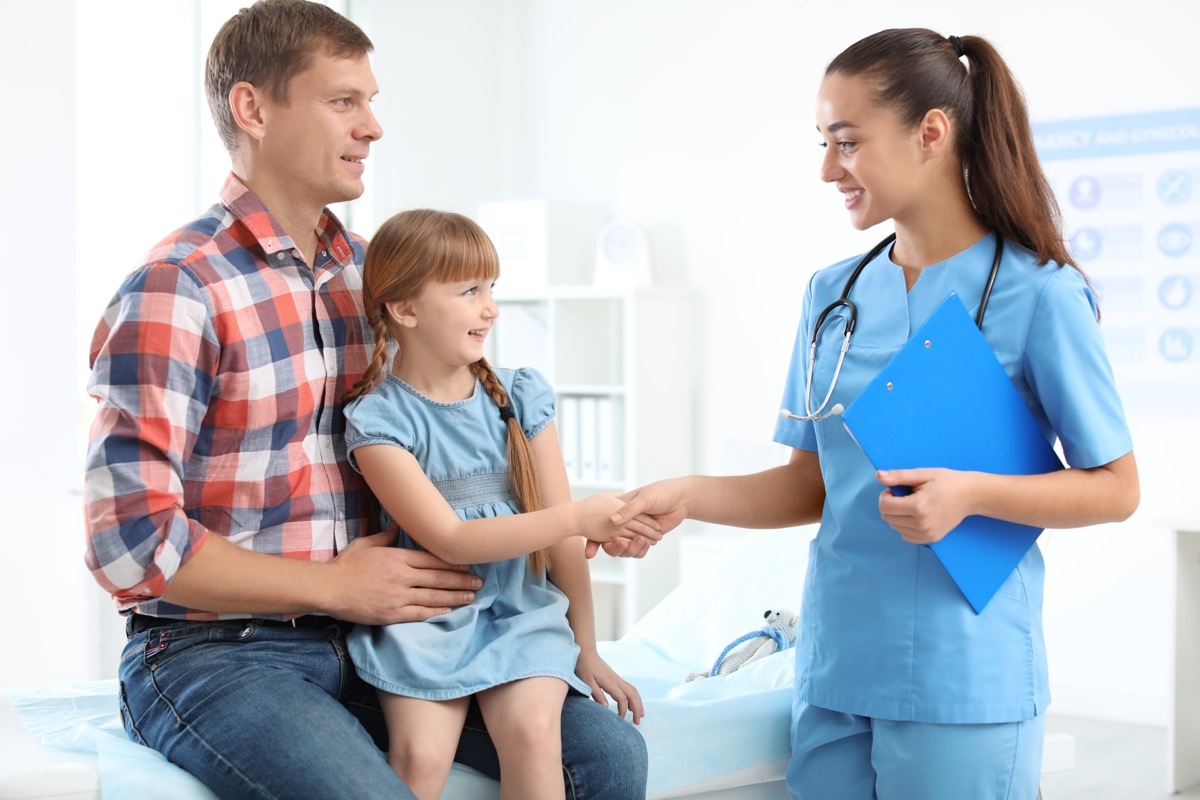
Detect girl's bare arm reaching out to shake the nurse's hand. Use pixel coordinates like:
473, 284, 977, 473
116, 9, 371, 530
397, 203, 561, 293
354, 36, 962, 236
354, 434, 662, 564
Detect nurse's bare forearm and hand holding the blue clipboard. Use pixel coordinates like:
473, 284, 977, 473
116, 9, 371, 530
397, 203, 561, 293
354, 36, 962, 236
878, 451, 1141, 545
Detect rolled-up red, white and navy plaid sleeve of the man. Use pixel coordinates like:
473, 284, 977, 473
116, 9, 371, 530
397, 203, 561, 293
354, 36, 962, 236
85, 264, 220, 609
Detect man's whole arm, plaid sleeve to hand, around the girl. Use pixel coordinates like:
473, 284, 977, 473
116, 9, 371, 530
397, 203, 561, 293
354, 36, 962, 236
86, 263, 478, 622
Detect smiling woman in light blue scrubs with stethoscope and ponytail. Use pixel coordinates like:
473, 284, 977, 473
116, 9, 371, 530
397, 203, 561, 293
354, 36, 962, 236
614, 30, 1139, 800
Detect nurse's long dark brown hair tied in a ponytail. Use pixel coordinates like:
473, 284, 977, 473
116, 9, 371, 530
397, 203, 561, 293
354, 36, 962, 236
826, 28, 1079, 270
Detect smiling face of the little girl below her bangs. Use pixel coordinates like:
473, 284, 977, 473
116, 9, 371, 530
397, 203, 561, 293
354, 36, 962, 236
406, 278, 500, 367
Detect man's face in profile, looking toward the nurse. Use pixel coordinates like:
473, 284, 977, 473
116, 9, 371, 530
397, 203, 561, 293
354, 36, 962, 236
254, 48, 383, 209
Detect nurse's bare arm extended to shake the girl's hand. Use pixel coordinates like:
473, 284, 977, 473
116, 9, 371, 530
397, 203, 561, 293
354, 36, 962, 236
613, 449, 826, 533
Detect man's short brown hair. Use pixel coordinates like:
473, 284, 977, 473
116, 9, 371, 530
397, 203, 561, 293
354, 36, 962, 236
204, 0, 374, 152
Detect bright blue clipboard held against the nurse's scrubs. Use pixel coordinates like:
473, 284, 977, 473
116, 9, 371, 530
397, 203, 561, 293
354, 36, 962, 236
842, 291, 1062, 614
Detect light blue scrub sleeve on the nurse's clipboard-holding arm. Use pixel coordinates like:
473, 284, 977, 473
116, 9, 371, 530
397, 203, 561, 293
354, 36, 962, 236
1025, 265, 1133, 469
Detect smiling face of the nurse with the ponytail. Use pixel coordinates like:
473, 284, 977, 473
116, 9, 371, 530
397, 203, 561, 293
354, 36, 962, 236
817, 74, 926, 230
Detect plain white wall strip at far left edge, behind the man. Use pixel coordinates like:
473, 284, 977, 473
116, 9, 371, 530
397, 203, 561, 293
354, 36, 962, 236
0, 0, 88, 682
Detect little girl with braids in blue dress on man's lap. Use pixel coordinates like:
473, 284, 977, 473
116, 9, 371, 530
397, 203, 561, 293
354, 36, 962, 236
346, 210, 661, 800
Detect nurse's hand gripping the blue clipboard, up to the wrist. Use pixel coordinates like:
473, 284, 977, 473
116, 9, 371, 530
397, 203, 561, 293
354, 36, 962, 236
875, 468, 972, 545
